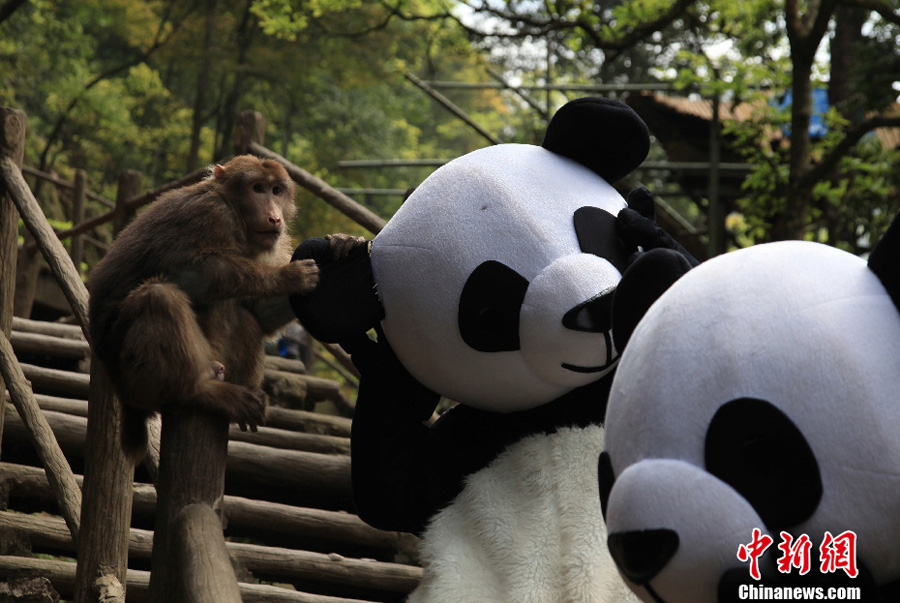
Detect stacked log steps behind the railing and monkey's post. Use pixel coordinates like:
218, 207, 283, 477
0, 319, 421, 603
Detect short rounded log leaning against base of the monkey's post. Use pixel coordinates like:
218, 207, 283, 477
165, 503, 242, 603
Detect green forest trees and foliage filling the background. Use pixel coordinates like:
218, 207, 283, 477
0, 0, 900, 266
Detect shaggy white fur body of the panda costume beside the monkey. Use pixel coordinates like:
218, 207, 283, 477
409, 426, 637, 603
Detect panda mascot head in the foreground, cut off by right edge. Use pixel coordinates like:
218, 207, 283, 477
600, 215, 900, 603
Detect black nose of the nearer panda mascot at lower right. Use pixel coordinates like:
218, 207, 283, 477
607, 528, 678, 584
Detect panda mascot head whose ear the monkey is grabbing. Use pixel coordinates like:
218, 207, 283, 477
292, 98, 649, 412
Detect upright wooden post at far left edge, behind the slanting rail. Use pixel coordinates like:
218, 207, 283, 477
0, 107, 26, 458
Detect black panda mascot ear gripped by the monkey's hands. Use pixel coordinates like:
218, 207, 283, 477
290, 238, 384, 343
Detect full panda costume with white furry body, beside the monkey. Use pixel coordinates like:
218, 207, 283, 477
292, 98, 696, 603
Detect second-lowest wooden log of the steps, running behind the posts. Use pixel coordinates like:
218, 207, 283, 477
0, 511, 422, 600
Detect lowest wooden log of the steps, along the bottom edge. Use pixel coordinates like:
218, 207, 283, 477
0, 556, 376, 603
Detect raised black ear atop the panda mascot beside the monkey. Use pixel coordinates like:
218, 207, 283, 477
541, 97, 650, 184
